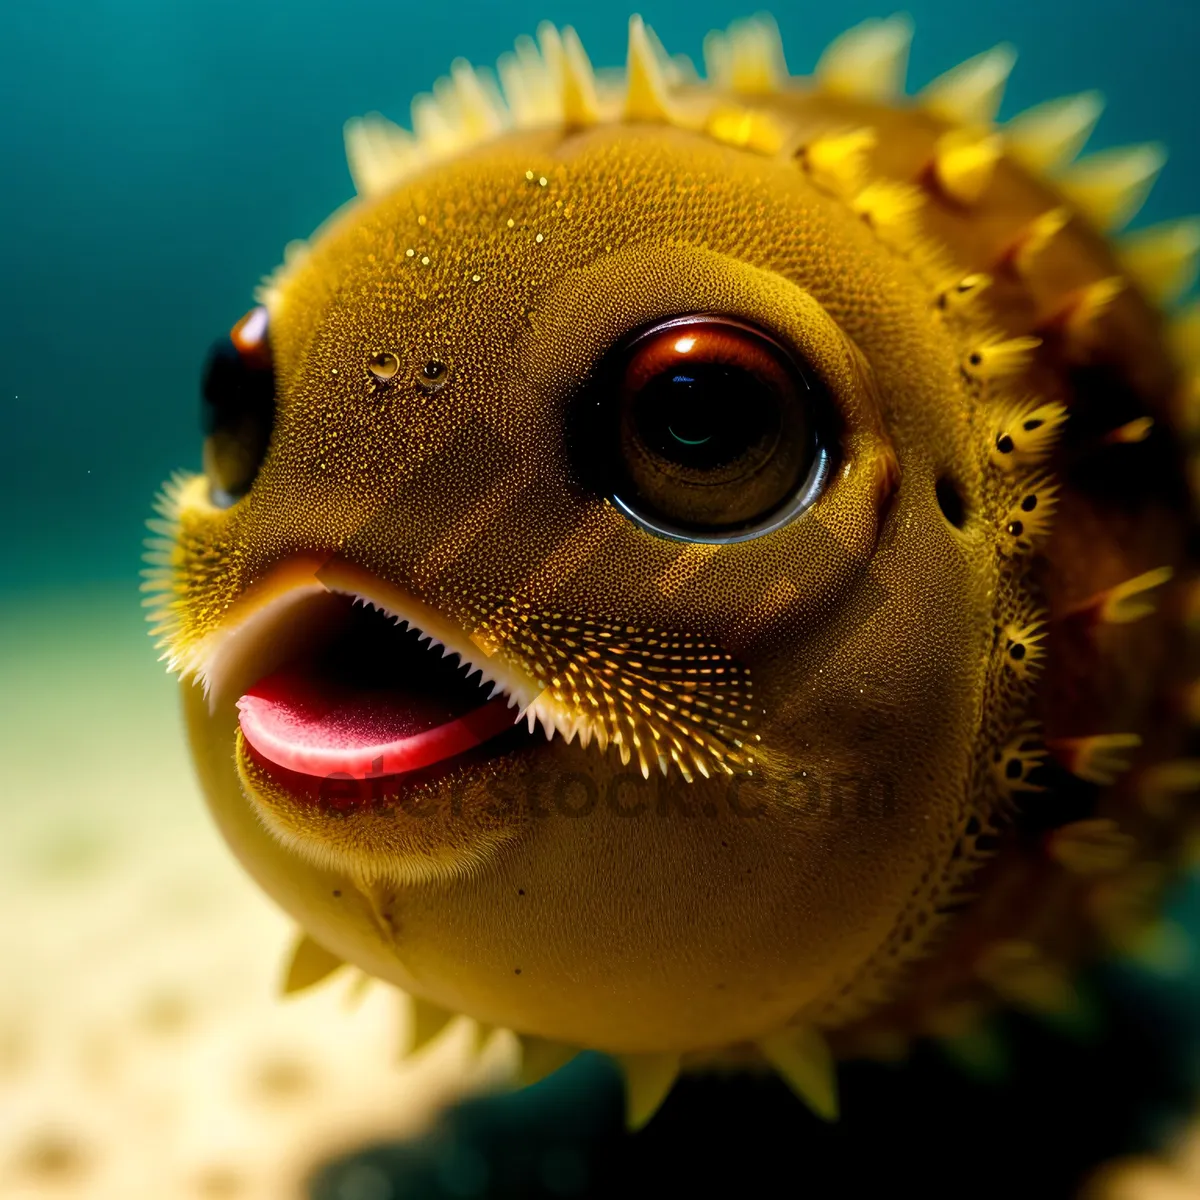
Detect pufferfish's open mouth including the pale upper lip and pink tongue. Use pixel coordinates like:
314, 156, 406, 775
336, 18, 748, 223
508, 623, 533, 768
202, 561, 549, 792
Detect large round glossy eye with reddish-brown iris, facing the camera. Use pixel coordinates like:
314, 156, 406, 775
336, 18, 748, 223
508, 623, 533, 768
588, 316, 829, 541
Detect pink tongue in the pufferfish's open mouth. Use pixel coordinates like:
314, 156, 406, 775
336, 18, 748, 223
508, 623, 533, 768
238, 670, 515, 779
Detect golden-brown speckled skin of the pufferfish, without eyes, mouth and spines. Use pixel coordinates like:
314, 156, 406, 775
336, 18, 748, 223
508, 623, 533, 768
154, 16, 1183, 1070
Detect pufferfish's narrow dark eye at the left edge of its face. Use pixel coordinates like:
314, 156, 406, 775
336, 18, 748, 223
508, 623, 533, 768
200, 308, 275, 508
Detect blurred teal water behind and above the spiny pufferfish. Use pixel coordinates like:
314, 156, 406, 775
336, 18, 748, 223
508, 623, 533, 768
0, 0, 1200, 592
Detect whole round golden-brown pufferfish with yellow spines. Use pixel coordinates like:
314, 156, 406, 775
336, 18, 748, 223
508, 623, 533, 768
146, 17, 1200, 1127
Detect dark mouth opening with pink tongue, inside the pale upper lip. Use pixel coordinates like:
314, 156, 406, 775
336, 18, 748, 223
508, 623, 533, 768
238, 595, 535, 779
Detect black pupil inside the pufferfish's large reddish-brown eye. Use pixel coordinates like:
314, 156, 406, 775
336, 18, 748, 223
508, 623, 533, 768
632, 362, 779, 470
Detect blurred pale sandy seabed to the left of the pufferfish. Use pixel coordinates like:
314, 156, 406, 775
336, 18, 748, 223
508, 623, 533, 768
0, 589, 505, 1200
